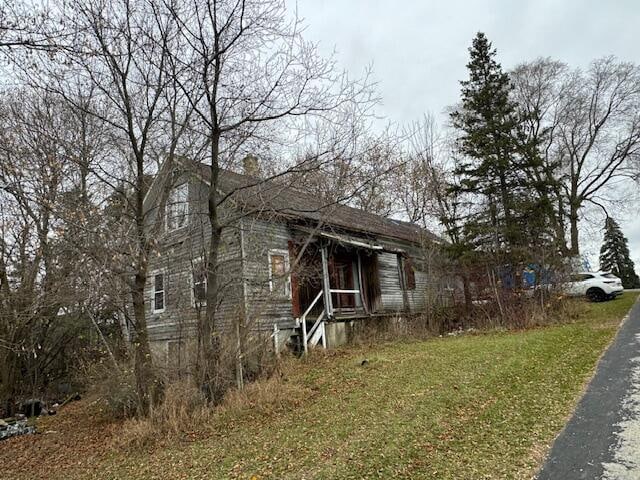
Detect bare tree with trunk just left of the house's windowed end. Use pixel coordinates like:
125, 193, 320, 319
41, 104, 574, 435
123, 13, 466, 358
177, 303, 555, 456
17, 0, 195, 412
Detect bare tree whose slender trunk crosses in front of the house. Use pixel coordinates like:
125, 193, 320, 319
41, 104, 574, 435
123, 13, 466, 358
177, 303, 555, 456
162, 0, 370, 400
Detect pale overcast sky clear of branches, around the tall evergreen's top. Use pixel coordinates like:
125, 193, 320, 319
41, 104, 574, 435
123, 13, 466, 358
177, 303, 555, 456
298, 0, 640, 271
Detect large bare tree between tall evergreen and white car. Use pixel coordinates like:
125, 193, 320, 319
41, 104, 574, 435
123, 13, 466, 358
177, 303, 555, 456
511, 57, 640, 255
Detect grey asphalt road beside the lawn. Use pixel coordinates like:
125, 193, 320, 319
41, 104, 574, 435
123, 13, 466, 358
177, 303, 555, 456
536, 302, 640, 480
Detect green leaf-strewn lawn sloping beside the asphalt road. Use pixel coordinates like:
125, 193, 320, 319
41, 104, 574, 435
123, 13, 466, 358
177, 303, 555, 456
65, 293, 636, 480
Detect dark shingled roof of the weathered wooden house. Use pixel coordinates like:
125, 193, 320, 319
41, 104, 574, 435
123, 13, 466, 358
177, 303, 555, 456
198, 164, 442, 243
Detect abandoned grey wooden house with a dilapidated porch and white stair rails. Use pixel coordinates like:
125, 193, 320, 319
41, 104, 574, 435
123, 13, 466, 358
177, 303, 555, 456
145, 159, 439, 359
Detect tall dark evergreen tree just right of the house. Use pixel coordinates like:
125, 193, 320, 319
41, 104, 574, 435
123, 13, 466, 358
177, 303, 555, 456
451, 33, 548, 258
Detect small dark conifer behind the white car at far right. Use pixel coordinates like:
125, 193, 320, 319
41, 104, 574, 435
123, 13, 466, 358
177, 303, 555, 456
600, 217, 640, 288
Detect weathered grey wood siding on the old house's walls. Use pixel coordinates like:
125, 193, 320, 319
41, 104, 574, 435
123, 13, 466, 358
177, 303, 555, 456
145, 167, 444, 355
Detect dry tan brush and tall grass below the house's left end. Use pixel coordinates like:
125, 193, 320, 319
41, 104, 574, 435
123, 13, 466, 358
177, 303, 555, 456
79, 324, 284, 448
